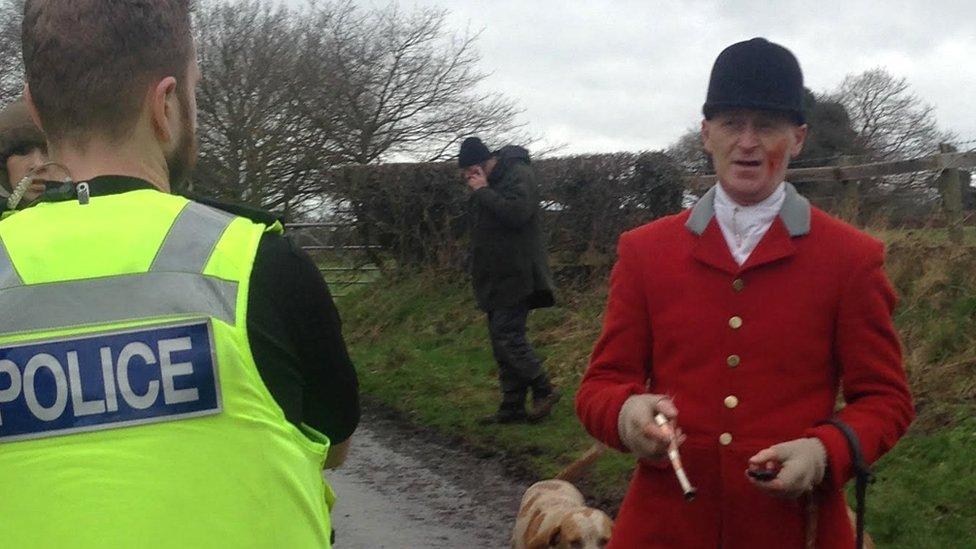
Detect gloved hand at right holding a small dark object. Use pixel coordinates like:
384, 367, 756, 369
749, 438, 827, 498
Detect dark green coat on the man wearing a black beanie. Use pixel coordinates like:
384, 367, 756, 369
469, 147, 555, 311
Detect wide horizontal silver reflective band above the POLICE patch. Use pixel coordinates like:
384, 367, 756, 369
0, 273, 237, 336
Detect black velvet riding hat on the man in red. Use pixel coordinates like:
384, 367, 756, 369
702, 38, 804, 124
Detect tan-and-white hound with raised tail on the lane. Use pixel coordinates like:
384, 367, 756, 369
512, 444, 613, 549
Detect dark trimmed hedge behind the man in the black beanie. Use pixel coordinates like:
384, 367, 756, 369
327, 152, 685, 267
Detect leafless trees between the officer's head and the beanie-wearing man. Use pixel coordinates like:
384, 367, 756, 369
194, 0, 524, 213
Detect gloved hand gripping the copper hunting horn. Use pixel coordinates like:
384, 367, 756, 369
617, 395, 684, 459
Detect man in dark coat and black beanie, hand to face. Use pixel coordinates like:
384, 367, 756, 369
458, 137, 560, 423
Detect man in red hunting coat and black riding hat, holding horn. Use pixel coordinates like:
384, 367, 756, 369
576, 38, 914, 549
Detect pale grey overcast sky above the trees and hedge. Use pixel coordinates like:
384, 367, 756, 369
283, 0, 976, 153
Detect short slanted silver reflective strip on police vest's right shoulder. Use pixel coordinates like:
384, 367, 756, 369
149, 202, 234, 273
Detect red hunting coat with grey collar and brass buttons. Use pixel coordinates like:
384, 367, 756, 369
576, 184, 914, 549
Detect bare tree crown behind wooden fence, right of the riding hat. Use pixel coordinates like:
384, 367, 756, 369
834, 67, 953, 160
